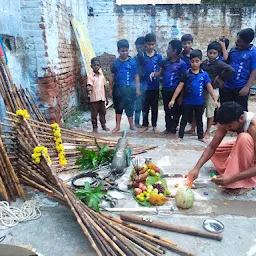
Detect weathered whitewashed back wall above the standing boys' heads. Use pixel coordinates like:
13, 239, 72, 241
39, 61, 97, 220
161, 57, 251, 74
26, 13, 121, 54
88, 0, 256, 58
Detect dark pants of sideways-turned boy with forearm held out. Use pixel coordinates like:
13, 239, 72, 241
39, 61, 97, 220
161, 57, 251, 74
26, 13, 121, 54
162, 89, 181, 133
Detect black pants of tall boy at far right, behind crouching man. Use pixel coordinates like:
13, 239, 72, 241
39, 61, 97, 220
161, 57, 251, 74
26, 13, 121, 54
220, 87, 249, 111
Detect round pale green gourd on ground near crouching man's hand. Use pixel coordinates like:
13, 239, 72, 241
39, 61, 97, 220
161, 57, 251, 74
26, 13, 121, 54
175, 187, 194, 209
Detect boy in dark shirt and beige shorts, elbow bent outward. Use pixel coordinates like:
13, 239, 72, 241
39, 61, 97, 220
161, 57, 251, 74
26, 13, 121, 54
201, 41, 235, 139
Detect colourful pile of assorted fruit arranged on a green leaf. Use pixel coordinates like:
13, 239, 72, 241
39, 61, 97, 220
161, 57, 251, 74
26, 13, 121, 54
129, 161, 170, 206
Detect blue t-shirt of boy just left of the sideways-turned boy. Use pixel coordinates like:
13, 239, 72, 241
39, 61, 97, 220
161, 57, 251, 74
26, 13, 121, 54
143, 51, 162, 90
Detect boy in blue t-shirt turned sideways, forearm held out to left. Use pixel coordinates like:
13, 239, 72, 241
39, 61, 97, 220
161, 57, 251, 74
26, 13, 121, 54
151, 40, 187, 134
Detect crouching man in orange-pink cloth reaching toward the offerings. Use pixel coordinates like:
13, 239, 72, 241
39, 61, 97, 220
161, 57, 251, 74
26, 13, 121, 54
187, 102, 256, 195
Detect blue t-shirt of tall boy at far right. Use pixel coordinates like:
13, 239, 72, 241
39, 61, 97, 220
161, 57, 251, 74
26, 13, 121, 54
224, 45, 256, 88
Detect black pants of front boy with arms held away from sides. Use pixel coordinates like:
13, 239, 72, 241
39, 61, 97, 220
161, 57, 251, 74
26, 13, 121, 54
179, 104, 204, 139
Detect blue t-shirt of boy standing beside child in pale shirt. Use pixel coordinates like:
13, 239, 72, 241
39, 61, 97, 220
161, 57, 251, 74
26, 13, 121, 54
111, 57, 139, 87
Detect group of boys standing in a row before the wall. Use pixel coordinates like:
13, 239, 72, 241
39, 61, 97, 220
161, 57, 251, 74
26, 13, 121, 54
87, 28, 256, 142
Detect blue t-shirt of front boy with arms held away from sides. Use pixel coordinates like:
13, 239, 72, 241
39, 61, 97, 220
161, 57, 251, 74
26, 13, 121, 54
181, 69, 211, 105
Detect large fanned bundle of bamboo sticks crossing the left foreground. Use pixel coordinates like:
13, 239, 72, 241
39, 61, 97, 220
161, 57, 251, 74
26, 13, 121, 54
0, 113, 193, 256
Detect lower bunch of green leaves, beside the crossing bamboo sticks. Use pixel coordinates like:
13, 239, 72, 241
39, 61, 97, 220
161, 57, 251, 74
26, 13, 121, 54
75, 181, 106, 212
